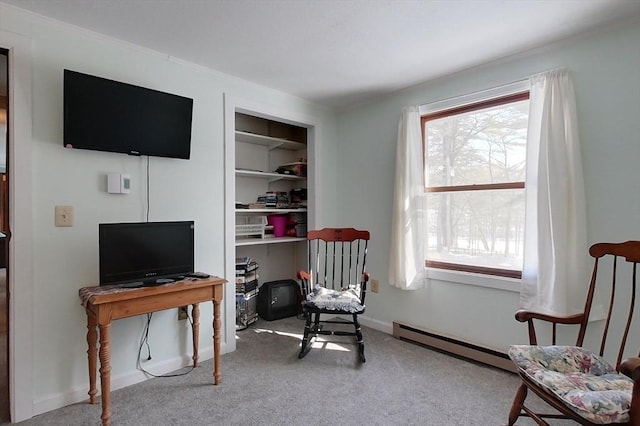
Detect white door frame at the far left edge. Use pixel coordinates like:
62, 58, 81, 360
0, 30, 33, 422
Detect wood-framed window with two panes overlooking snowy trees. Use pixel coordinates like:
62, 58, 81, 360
421, 91, 529, 278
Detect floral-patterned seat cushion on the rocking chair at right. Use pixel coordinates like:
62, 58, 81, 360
509, 345, 633, 424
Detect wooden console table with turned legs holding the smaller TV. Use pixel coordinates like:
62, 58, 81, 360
79, 277, 226, 425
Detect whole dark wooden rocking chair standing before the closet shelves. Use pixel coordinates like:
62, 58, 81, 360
298, 228, 369, 362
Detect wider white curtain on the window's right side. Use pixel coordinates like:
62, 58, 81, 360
520, 69, 591, 315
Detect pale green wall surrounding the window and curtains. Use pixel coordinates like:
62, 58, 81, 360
337, 22, 640, 350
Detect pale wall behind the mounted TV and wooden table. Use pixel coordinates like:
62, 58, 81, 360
0, 4, 336, 420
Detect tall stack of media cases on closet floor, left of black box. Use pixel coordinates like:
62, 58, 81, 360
236, 257, 258, 330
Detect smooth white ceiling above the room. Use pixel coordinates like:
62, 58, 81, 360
0, 0, 640, 108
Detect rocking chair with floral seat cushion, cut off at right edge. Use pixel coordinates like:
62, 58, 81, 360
508, 241, 640, 426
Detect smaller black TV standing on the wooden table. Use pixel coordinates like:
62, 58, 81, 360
98, 221, 194, 285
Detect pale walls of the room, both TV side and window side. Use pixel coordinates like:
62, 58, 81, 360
0, 0, 640, 420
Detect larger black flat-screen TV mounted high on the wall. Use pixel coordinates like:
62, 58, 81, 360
63, 70, 193, 159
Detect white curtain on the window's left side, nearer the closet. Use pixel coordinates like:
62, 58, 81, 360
389, 106, 426, 290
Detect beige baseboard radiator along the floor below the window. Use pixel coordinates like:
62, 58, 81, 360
393, 321, 516, 373
